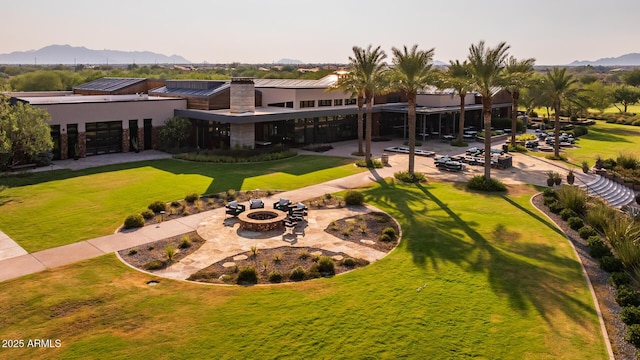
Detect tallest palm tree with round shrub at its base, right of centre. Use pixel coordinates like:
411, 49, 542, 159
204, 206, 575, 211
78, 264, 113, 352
467, 41, 509, 181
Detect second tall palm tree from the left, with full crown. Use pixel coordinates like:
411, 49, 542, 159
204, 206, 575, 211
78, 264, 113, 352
390, 45, 435, 175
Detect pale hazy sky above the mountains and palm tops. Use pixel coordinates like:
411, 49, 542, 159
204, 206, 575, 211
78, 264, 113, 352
5, 0, 640, 65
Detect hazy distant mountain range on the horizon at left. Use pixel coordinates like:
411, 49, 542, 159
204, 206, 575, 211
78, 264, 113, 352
0, 45, 191, 65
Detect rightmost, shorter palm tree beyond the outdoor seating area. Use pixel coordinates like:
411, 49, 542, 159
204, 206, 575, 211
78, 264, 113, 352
542, 67, 578, 158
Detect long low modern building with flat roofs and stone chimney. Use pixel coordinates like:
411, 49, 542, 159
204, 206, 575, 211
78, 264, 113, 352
6, 75, 511, 159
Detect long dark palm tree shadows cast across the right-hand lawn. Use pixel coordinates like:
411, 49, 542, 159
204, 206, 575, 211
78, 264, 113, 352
380, 184, 593, 328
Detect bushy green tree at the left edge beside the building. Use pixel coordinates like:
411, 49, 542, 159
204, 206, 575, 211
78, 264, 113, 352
0, 99, 53, 166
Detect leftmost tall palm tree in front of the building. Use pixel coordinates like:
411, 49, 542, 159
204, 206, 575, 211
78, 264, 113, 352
349, 45, 387, 164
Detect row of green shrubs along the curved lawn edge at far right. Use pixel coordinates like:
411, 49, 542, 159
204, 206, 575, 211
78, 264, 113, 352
543, 186, 640, 348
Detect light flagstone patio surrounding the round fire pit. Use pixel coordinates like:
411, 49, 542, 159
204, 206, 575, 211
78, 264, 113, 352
154, 206, 396, 280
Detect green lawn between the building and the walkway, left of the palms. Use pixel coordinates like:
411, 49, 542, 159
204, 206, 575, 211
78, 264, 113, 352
0, 156, 363, 252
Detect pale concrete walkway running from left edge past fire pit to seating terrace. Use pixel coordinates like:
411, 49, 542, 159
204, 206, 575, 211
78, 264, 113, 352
0, 140, 580, 281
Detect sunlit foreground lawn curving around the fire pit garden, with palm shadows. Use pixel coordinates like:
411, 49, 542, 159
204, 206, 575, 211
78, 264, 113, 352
0, 183, 607, 359
